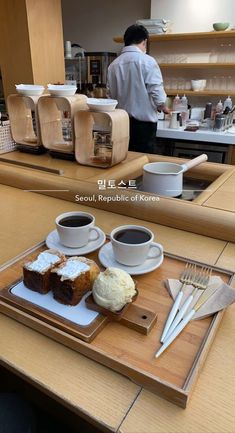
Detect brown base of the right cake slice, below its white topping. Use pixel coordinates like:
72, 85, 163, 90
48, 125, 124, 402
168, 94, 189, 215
50, 271, 91, 305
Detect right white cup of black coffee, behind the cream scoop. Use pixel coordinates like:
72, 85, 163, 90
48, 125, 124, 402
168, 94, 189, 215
110, 225, 163, 266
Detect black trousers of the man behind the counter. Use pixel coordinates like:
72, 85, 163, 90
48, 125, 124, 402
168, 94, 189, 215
129, 117, 157, 153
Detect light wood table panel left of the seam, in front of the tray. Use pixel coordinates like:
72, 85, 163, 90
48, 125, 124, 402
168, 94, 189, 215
0, 313, 140, 432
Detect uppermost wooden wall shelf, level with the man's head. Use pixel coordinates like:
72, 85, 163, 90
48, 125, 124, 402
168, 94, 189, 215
113, 30, 235, 43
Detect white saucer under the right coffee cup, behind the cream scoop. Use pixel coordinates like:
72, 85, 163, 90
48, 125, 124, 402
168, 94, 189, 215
99, 242, 164, 275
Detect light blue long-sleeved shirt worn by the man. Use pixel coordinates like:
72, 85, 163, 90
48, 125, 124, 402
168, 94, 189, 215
107, 45, 166, 122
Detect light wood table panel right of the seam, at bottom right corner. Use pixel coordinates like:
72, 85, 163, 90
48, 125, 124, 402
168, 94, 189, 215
119, 305, 235, 433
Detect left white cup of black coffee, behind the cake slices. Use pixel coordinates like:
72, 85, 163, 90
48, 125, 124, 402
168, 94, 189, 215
55, 212, 100, 248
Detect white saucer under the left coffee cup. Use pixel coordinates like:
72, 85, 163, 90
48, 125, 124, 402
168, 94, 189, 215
46, 227, 106, 256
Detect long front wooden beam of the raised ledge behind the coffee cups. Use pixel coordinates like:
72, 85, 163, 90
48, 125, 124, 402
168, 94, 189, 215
0, 161, 235, 241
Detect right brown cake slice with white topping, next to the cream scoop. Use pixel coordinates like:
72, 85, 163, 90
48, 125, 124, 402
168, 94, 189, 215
50, 257, 100, 305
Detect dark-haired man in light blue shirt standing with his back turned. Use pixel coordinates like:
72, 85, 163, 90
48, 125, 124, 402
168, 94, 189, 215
107, 24, 169, 153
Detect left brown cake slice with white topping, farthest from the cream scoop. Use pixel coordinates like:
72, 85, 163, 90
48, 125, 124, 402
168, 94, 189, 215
23, 249, 66, 294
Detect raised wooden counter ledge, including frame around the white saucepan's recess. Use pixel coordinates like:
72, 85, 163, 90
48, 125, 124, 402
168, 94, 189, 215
0, 152, 235, 242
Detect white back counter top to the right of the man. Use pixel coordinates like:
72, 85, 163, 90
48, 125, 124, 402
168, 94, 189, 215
157, 120, 235, 145
